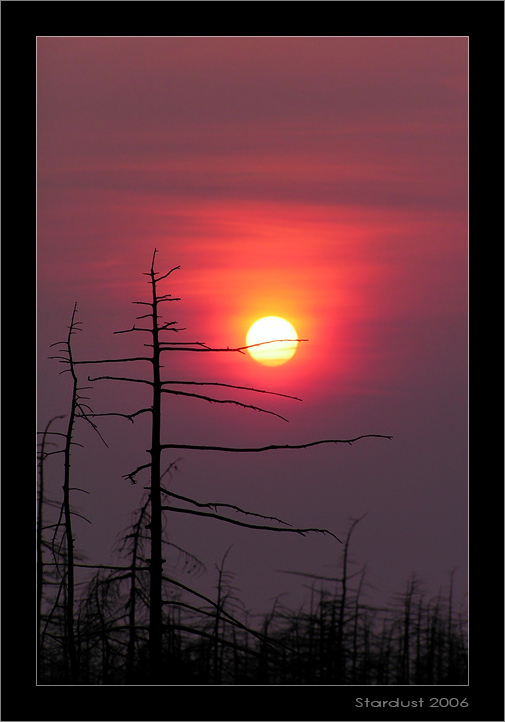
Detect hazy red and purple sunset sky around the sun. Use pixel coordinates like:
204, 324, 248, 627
37, 36, 468, 612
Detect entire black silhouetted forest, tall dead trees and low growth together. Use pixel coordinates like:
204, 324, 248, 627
37, 249, 467, 685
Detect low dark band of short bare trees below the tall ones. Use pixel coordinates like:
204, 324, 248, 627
39, 498, 468, 685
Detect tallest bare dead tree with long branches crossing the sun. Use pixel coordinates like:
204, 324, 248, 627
67, 249, 391, 683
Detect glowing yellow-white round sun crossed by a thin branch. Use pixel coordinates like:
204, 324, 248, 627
246, 316, 298, 366
